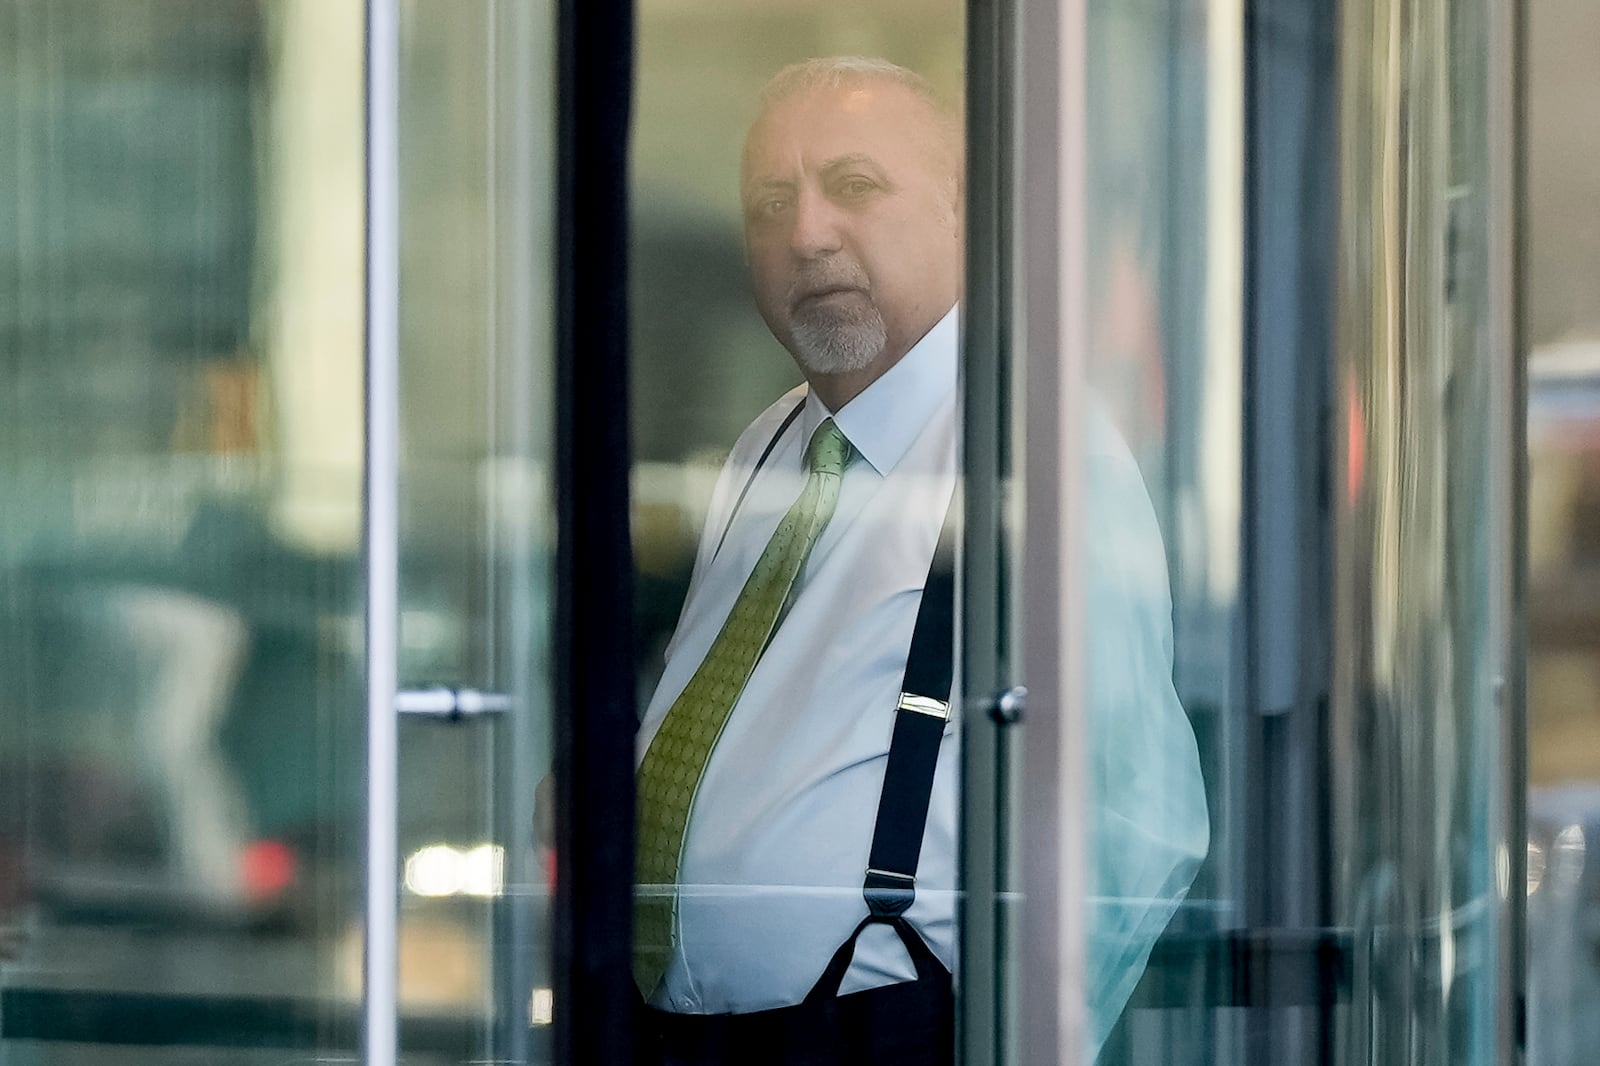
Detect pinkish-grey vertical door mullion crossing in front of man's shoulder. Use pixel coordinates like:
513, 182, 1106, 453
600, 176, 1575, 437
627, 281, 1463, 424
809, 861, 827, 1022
1013, 0, 1091, 1063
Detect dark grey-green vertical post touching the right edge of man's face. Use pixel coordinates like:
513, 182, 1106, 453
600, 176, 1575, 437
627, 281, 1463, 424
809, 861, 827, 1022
957, 0, 1018, 1066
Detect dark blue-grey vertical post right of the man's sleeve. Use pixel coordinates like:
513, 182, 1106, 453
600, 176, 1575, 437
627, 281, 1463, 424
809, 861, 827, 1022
1242, 0, 1339, 1063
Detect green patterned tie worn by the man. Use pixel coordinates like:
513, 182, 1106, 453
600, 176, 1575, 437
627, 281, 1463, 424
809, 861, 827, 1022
634, 419, 851, 999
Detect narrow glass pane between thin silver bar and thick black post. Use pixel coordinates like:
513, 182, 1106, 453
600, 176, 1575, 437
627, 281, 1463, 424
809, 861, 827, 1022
398, 0, 555, 1063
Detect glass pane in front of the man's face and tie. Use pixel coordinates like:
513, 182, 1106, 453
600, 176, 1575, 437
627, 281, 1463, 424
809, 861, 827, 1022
630, 0, 965, 1063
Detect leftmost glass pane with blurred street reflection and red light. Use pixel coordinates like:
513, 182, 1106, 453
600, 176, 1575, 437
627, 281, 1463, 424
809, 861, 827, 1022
0, 0, 363, 1064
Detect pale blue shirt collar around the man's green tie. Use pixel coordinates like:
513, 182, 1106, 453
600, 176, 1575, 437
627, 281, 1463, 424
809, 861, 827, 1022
802, 306, 962, 475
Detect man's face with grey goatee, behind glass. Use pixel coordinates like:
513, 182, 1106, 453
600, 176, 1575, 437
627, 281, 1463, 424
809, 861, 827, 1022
741, 80, 962, 382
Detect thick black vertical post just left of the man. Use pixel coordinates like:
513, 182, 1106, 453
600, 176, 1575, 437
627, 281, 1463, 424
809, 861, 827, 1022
553, 0, 637, 1066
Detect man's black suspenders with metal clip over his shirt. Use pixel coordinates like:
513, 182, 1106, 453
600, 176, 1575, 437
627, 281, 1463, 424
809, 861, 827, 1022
717, 400, 955, 999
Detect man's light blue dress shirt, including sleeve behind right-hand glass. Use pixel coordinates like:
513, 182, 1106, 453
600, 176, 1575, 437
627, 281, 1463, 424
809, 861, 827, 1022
637, 302, 1206, 1047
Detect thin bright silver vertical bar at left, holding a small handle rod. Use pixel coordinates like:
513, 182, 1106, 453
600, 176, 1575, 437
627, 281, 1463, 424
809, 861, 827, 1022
362, 0, 400, 1066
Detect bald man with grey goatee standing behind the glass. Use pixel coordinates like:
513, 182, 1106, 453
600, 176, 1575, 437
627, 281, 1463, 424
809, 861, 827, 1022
635, 59, 1205, 1066
